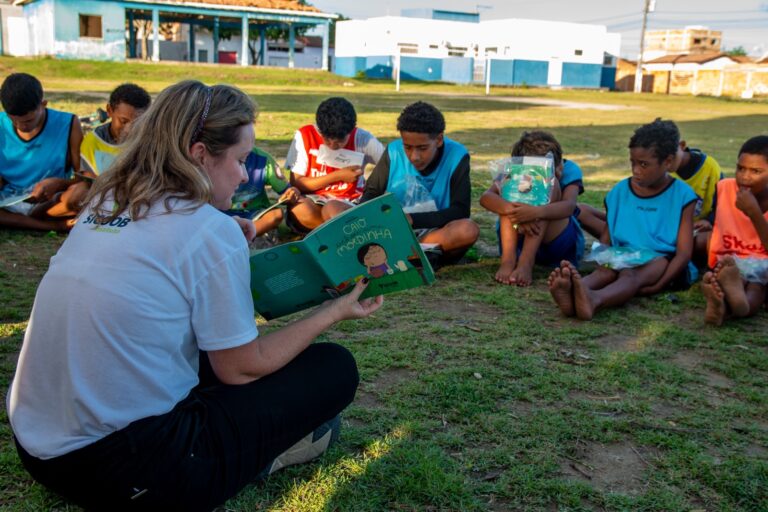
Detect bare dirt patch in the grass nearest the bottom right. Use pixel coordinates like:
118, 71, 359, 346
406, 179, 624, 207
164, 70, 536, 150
560, 442, 654, 495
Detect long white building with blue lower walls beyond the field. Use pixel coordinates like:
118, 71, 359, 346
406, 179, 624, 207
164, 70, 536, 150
334, 9, 621, 88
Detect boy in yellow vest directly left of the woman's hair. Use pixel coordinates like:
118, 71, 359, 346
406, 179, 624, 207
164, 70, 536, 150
80, 83, 152, 175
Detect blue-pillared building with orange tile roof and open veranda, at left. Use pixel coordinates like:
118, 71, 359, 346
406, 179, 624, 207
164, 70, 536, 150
7, 0, 337, 69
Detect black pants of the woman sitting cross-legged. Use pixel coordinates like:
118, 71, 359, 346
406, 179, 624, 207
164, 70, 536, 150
16, 343, 359, 511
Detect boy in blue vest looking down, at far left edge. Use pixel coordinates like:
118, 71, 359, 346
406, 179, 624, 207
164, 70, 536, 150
0, 73, 87, 231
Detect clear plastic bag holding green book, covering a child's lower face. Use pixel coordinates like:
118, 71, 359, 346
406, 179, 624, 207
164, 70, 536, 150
491, 153, 555, 206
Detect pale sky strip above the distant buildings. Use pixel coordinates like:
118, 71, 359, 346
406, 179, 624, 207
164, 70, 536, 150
310, 0, 768, 59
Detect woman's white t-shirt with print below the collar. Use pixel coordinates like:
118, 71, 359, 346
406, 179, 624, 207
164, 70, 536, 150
7, 198, 258, 459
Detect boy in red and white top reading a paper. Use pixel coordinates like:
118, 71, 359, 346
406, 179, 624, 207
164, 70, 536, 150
285, 98, 384, 231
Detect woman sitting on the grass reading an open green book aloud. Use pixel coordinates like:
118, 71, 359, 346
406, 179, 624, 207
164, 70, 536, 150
8, 81, 382, 510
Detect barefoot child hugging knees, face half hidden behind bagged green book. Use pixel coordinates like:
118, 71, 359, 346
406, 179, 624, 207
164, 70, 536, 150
480, 131, 584, 286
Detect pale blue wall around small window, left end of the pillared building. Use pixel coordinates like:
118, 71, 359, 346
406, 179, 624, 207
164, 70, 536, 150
51, 0, 125, 60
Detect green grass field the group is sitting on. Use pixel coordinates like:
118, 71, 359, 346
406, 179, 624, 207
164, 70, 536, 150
0, 58, 768, 511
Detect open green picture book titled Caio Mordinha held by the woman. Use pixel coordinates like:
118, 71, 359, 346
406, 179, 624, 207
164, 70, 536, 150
250, 194, 435, 320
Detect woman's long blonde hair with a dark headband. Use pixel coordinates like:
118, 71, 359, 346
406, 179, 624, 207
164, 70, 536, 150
86, 80, 256, 222
